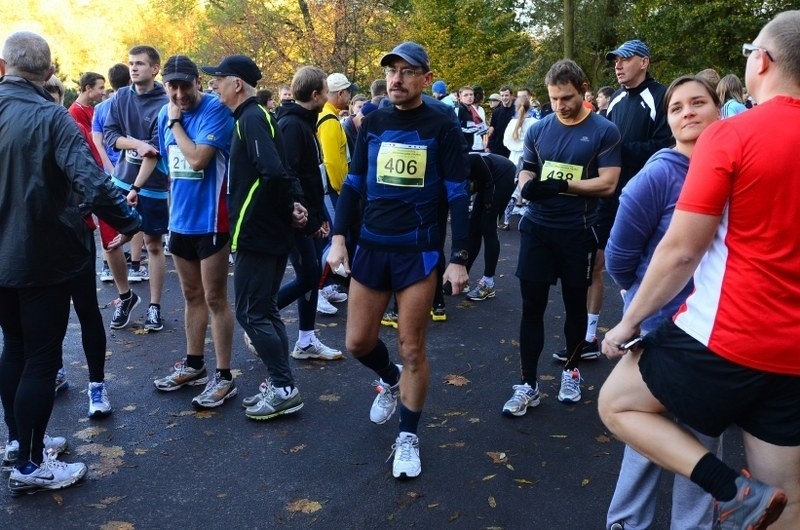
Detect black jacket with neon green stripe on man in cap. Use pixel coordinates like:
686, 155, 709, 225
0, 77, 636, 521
228, 97, 303, 255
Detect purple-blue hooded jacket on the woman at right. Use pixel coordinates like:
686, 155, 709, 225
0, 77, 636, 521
605, 149, 693, 332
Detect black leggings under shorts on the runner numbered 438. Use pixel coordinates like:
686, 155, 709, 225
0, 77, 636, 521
519, 280, 587, 386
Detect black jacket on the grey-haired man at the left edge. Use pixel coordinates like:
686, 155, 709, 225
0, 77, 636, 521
0, 75, 141, 288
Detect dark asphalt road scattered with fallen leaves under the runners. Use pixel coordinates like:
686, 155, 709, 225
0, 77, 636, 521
0, 229, 741, 530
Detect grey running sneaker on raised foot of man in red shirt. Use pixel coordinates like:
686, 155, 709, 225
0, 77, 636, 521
716, 469, 787, 530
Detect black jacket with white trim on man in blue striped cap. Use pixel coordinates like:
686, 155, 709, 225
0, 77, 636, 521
606, 74, 675, 189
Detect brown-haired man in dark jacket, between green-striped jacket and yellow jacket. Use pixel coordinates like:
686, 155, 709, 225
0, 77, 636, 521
278, 66, 342, 361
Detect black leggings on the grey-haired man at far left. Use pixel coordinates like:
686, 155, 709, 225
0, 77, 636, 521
0, 282, 70, 466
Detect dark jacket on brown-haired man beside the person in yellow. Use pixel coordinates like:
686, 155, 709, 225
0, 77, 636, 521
278, 102, 327, 234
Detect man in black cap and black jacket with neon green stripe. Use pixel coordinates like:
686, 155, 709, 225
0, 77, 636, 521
202, 55, 308, 420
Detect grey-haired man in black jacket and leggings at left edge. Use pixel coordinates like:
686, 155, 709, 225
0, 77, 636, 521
0, 32, 141, 494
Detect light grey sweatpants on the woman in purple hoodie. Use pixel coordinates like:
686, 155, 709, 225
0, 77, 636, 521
606, 425, 722, 530
